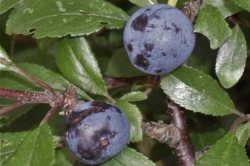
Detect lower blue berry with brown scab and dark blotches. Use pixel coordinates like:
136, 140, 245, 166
65, 101, 130, 164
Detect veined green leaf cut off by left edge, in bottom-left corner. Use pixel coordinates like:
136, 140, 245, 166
0, 131, 30, 165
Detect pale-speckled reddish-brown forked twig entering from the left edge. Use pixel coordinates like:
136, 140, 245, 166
0, 84, 81, 123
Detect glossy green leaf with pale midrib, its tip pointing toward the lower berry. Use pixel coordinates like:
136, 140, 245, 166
56, 37, 108, 100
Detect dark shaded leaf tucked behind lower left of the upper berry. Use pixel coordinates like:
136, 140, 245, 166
105, 47, 145, 77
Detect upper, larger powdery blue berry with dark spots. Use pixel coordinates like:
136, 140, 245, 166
123, 4, 195, 75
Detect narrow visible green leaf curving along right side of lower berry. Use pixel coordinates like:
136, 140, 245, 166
115, 101, 142, 142
